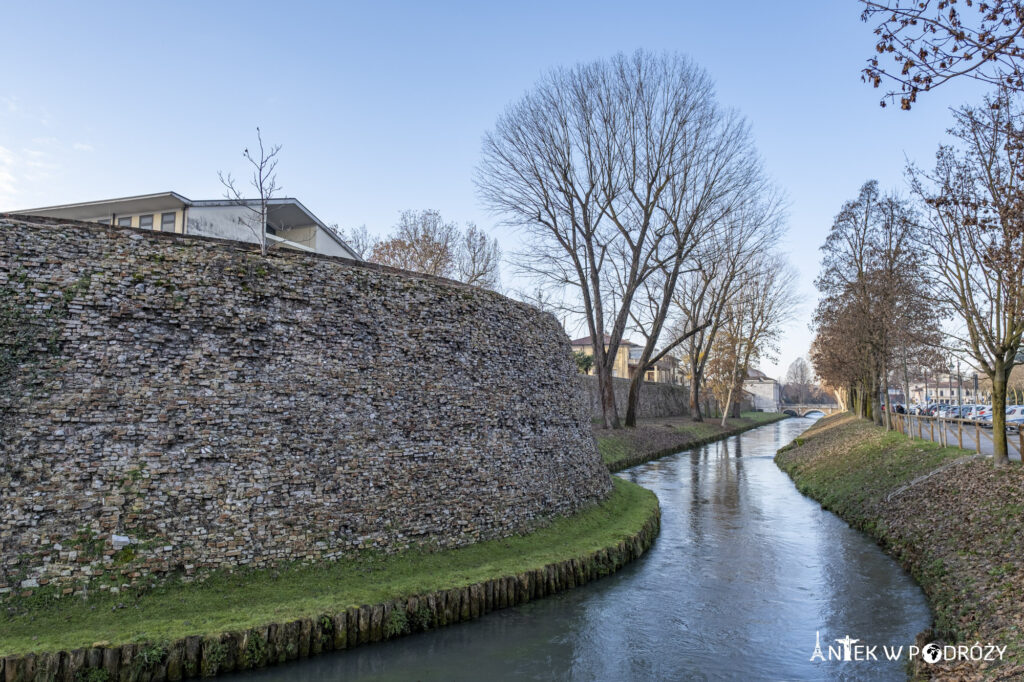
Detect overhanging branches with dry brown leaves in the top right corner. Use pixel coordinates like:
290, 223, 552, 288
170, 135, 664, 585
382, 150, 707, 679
861, 0, 1024, 109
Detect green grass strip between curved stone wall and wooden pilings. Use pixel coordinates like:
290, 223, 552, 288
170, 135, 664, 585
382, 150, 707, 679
0, 478, 657, 656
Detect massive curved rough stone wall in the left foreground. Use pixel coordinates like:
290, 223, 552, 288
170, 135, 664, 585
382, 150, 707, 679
0, 215, 610, 591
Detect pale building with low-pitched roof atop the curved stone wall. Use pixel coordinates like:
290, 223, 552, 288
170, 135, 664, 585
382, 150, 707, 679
11, 191, 359, 260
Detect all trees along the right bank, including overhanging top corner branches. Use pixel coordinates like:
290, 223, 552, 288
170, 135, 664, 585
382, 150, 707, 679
811, 0, 1024, 465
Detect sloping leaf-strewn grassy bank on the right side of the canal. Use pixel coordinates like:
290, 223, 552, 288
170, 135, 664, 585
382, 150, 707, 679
775, 415, 1024, 680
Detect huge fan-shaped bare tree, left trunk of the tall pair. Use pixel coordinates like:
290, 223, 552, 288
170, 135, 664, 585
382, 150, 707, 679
477, 51, 733, 428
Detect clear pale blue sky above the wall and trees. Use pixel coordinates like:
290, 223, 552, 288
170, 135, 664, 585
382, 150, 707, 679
0, 0, 982, 376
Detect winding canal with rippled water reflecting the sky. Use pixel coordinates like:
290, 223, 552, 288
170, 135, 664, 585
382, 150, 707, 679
231, 419, 931, 682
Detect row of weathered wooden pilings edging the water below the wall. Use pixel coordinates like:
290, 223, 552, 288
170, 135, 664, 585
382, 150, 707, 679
0, 501, 660, 682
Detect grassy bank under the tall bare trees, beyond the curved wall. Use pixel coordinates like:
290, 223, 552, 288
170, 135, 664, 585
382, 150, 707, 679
594, 412, 788, 472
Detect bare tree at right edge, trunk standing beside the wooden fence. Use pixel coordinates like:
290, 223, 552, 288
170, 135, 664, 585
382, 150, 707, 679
909, 90, 1024, 465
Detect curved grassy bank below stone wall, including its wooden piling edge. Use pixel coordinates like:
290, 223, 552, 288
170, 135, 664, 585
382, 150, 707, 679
0, 479, 659, 682
